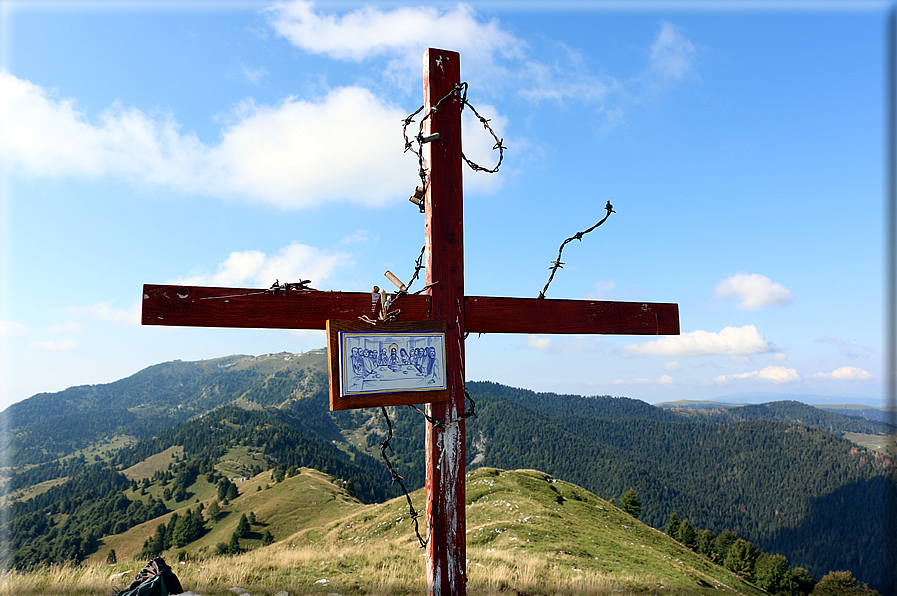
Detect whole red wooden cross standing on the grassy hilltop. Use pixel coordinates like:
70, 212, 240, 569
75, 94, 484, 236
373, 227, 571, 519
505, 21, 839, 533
143, 48, 679, 596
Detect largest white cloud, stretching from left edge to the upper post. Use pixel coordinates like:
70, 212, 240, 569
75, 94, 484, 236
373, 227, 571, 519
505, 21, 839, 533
0, 72, 428, 209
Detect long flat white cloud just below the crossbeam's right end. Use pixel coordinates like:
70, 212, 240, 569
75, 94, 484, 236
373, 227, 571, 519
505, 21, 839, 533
622, 325, 775, 358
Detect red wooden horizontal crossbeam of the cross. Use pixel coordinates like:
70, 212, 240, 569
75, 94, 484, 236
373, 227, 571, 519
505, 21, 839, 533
142, 284, 679, 335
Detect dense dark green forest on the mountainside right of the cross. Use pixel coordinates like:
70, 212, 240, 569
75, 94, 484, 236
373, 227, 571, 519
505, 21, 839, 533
458, 383, 897, 587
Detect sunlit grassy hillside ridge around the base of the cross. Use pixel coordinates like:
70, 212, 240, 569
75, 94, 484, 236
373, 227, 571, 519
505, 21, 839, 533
12, 468, 765, 596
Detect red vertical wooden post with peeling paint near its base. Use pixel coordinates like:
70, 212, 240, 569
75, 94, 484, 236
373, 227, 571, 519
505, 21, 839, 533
423, 48, 467, 596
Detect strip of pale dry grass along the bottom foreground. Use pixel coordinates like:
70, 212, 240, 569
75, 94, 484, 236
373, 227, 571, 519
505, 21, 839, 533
0, 541, 728, 596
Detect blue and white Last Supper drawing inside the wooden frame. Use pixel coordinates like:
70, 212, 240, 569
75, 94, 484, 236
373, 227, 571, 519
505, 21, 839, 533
339, 331, 446, 396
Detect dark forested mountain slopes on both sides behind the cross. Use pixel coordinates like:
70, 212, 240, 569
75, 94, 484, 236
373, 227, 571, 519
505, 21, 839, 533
0, 351, 894, 585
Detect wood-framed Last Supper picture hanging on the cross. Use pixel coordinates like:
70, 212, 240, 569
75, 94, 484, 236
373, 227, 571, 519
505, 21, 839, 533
327, 321, 448, 410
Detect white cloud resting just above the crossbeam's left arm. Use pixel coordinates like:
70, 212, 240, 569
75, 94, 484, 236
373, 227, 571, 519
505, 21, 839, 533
172, 242, 352, 288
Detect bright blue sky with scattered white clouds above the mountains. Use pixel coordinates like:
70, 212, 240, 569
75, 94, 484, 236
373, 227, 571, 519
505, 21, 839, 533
0, 1, 890, 408
